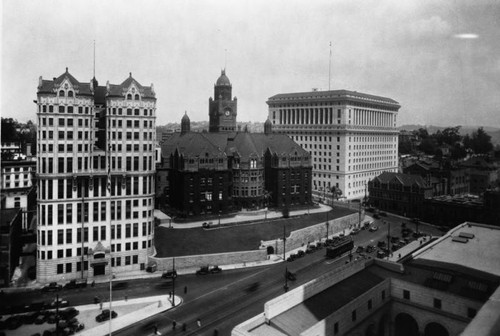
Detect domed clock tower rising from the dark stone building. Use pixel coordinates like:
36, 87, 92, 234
208, 70, 238, 133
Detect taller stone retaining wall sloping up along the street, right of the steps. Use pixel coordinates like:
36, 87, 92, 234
261, 213, 364, 254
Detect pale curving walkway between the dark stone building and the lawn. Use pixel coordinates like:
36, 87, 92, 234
160, 204, 332, 229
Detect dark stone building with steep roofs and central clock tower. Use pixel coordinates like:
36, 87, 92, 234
157, 71, 311, 216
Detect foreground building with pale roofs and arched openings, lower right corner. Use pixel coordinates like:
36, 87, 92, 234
231, 222, 500, 336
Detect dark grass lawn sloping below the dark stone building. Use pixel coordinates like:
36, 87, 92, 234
155, 208, 356, 258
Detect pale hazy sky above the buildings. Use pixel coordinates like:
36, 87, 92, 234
0, 0, 500, 127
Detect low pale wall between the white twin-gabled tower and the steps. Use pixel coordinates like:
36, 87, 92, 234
150, 250, 267, 271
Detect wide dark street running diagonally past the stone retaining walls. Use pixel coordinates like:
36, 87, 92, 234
3, 215, 441, 335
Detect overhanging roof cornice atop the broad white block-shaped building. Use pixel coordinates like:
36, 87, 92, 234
267, 90, 399, 106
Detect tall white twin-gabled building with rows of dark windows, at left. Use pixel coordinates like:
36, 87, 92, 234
36, 68, 156, 282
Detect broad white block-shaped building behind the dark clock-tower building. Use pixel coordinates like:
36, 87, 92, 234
267, 90, 400, 200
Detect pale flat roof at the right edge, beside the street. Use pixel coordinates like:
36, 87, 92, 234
414, 222, 500, 276
